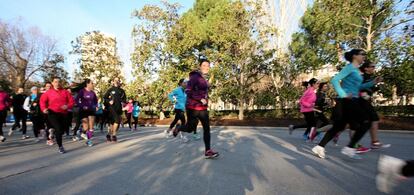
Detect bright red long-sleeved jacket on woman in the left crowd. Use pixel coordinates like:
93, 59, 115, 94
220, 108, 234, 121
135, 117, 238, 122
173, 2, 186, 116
40, 88, 75, 114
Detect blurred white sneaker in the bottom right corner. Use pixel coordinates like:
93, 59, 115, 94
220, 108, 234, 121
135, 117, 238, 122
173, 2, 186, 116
376, 155, 406, 193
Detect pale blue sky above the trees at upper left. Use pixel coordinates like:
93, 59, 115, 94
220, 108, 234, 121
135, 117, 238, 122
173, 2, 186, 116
0, 0, 194, 78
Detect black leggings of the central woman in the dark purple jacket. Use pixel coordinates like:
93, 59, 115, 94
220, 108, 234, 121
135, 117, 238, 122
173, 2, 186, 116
178, 109, 211, 151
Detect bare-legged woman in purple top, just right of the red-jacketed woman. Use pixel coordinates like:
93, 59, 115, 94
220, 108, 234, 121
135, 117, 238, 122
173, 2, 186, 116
76, 79, 98, 146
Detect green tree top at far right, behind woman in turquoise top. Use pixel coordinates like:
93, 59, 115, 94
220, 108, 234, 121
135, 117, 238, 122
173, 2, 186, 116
289, 0, 414, 103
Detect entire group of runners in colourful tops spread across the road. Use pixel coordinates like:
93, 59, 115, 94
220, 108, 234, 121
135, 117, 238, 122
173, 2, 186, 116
0, 49, 414, 192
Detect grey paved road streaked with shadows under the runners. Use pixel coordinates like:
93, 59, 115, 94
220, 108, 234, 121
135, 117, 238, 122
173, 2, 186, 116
0, 127, 414, 195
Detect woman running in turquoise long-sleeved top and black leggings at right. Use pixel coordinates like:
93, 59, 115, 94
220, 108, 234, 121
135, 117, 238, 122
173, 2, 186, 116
312, 49, 376, 159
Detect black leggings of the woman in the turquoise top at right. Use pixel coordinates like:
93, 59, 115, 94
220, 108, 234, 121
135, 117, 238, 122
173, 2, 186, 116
319, 98, 371, 148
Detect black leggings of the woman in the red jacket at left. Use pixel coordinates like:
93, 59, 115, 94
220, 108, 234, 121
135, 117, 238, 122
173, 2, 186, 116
48, 110, 69, 147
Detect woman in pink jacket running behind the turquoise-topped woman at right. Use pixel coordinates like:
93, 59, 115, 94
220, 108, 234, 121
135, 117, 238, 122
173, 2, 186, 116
290, 78, 319, 141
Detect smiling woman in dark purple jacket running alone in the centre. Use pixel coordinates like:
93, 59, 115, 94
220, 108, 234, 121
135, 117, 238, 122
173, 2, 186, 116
173, 60, 219, 159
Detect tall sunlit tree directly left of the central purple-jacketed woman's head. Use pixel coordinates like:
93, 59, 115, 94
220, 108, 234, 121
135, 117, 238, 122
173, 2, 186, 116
128, 1, 186, 111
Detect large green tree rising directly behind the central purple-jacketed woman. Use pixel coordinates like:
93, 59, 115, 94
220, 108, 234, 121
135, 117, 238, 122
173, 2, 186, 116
169, 0, 273, 120
